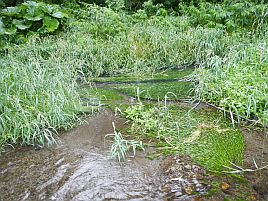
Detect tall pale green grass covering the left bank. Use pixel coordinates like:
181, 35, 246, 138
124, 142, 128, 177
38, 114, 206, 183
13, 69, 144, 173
0, 38, 80, 148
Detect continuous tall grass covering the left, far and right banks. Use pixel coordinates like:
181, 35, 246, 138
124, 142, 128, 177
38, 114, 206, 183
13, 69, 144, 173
0, 1, 268, 151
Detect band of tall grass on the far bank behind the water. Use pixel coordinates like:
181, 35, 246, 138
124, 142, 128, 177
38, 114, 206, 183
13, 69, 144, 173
70, 6, 228, 76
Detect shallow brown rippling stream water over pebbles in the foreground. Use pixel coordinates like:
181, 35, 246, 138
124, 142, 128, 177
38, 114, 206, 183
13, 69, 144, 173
0, 76, 268, 201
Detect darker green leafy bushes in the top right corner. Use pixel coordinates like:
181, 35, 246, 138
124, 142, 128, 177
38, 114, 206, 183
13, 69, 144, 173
180, 1, 268, 31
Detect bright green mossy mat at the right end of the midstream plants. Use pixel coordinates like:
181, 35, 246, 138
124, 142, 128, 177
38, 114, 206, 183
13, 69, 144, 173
183, 128, 244, 171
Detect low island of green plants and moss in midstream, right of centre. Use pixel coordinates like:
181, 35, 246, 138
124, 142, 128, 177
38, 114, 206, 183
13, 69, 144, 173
124, 103, 244, 172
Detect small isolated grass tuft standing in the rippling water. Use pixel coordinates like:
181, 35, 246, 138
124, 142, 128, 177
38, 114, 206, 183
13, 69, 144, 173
105, 122, 144, 162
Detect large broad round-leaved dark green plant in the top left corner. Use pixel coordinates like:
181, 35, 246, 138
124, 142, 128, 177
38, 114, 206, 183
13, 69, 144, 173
0, 1, 69, 35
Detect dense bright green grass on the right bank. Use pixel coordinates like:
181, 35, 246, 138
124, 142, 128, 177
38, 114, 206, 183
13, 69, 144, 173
197, 38, 268, 126
